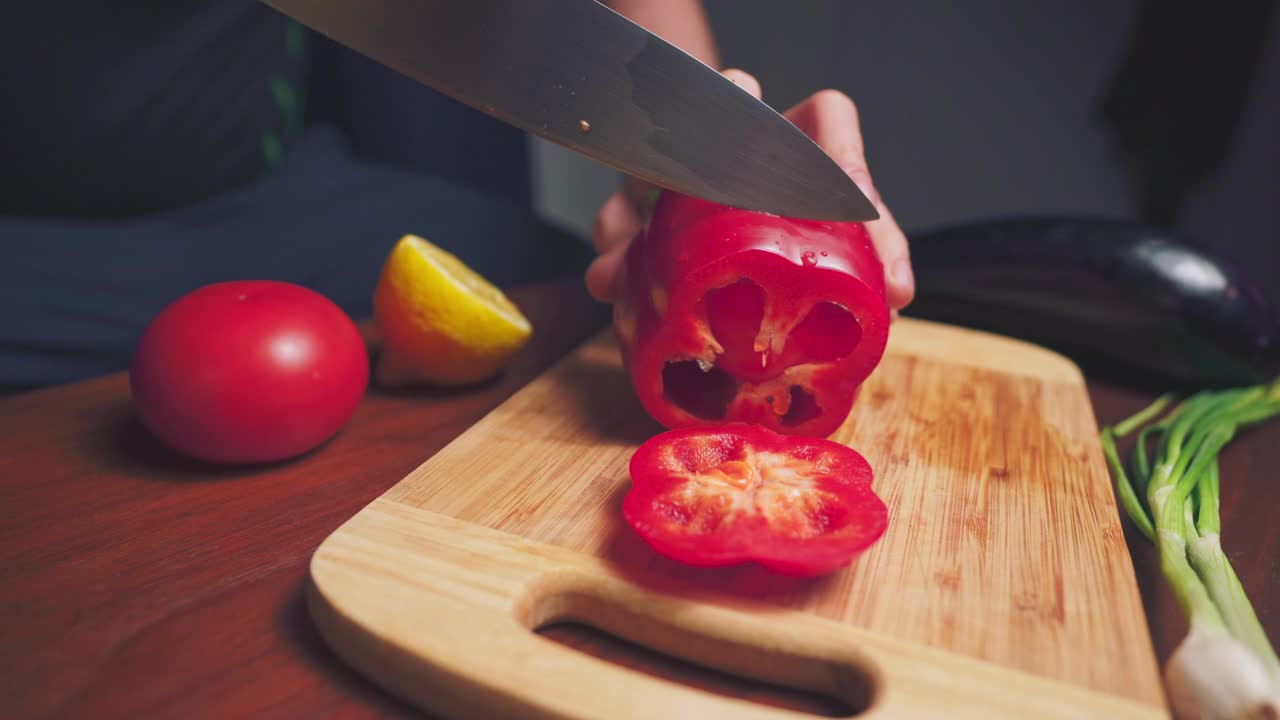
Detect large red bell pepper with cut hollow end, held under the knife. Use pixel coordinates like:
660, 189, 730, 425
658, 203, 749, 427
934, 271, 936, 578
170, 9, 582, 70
613, 192, 890, 437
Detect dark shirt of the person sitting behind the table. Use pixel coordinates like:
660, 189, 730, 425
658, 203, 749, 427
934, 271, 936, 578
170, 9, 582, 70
0, 0, 306, 219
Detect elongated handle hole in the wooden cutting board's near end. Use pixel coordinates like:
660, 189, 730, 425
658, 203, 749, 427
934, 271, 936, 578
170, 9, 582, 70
517, 591, 877, 717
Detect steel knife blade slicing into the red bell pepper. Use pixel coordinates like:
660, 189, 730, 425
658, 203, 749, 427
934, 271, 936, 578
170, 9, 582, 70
264, 0, 879, 222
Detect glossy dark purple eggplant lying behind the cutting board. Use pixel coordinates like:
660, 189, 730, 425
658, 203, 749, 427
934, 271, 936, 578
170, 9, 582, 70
902, 217, 1280, 389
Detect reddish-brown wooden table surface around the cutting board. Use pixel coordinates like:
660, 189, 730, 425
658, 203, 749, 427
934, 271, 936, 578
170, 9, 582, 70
0, 271, 1280, 719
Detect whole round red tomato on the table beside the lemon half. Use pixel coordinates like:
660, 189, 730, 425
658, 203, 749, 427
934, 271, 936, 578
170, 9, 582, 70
129, 281, 369, 462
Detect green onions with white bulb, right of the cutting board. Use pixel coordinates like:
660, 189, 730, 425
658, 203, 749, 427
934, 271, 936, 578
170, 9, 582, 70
1100, 378, 1280, 719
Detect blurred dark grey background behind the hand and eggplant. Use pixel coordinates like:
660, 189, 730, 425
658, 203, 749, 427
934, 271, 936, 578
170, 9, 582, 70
532, 0, 1280, 297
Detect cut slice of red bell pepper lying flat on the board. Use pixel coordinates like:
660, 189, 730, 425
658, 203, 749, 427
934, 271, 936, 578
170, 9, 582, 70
622, 423, 888, 577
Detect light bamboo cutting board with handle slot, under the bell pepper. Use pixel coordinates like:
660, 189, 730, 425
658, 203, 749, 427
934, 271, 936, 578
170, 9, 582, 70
311, 319, 1167, 720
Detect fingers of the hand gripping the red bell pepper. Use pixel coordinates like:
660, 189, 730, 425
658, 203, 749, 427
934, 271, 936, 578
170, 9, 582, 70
586, 70, 915, 313
